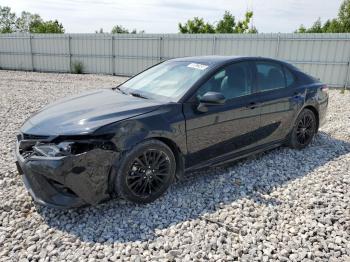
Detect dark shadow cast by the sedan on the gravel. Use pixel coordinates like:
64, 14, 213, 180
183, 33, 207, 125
37, 132, 350, 243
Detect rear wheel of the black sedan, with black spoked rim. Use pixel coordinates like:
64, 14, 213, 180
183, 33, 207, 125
288, 109, 317, 149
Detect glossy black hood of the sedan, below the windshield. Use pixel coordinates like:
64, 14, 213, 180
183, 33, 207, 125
21, 89, 161, 136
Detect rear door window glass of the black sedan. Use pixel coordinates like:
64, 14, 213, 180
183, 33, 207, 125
256, 62, 286, 92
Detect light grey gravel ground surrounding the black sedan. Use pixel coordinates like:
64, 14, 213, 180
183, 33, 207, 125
0, 71, 350, 261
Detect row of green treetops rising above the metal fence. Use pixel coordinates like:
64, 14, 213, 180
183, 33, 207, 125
0, 0, 350, 34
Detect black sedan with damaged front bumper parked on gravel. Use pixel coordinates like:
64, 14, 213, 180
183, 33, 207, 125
16, 56, 328, 208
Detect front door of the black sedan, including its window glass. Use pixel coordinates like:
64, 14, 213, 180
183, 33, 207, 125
184, 62, 260, 167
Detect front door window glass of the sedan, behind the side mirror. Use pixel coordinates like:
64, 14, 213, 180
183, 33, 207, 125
197, 62, 253, 100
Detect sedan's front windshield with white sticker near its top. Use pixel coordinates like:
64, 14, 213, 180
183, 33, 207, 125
119, 61, 208, 102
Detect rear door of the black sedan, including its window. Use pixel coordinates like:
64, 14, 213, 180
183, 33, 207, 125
255, 60, 302, 145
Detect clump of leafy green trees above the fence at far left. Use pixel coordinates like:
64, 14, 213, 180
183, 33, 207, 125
0, 6, 64, 33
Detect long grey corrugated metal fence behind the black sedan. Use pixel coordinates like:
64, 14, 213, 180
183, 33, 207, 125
0, 34, 350, 87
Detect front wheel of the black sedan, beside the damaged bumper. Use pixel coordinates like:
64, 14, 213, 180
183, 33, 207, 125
114, 139, 176, 204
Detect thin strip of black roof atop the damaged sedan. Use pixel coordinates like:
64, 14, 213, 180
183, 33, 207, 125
168, 55, 285, 66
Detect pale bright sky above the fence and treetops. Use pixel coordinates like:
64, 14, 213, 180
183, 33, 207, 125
0, 0, 342, 33
